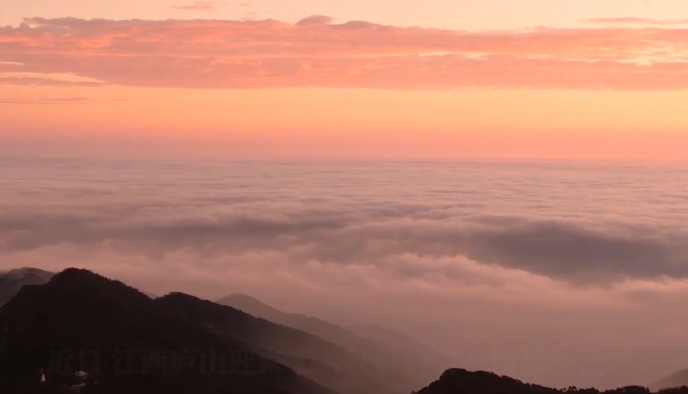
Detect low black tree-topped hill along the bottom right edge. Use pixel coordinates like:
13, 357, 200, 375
412, 369, 688, 394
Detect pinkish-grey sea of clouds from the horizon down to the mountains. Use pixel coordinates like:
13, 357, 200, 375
0, 159, 688, 387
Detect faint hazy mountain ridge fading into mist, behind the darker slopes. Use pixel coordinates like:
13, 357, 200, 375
217, 294, 454, 387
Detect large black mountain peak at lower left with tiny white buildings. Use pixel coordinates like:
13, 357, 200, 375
0, 269, 335, 394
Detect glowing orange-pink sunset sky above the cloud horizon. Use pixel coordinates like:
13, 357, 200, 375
0, 0, 688, 160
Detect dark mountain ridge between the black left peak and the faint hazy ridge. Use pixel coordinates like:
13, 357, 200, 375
155, 293, 420, 394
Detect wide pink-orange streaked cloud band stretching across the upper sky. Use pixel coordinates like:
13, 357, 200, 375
0, 16, 688, 90
